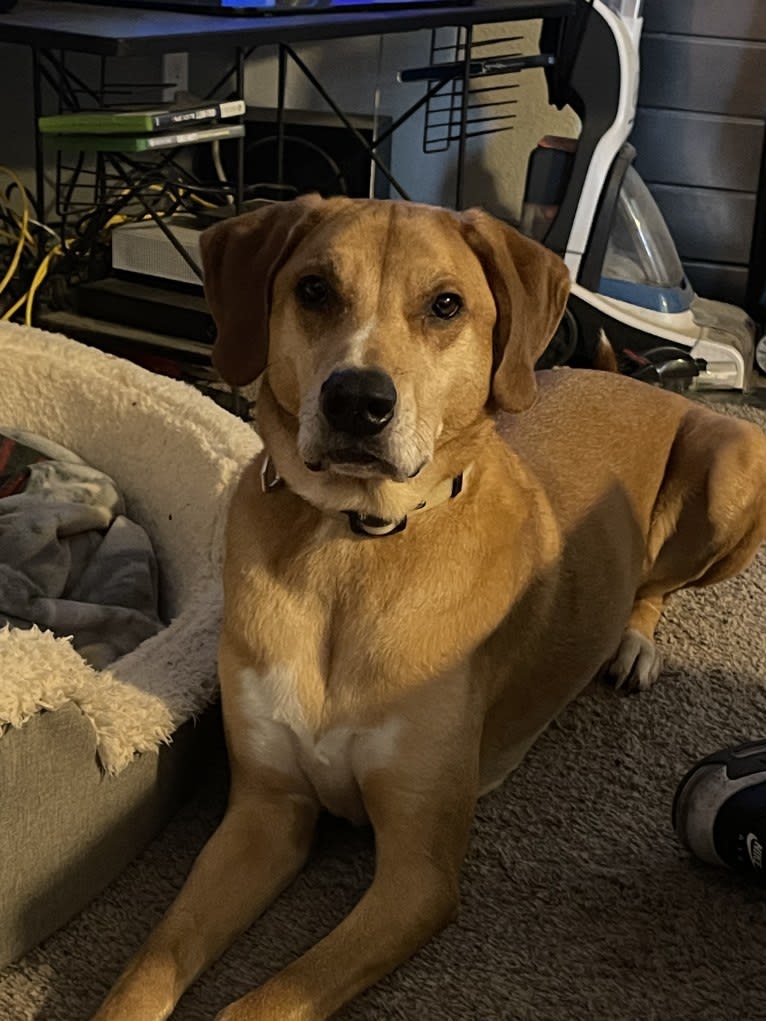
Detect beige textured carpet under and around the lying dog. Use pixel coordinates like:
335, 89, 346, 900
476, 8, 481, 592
0, 398, 766, 1021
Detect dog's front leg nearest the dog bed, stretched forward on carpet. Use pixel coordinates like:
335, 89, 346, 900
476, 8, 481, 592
94, 784, 317, 1021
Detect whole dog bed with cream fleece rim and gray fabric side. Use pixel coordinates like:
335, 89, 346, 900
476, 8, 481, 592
0, 324, 260, 966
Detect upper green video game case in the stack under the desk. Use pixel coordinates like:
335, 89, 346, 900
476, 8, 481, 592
38, 99, 245, 135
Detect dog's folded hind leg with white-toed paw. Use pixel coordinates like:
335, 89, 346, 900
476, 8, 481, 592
605, 407, 766, 690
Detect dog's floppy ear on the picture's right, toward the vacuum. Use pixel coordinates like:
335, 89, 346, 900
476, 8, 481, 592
461, 209, 570, 411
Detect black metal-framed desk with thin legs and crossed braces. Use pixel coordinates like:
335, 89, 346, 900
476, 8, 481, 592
0, 0, 578, 363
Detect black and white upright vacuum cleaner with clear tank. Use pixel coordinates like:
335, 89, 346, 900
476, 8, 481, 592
520, 0, 756, 390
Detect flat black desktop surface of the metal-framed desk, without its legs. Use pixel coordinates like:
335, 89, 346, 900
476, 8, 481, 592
0, 0, 576, 56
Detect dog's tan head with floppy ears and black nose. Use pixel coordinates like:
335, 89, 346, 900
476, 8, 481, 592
201, 195, 569, 481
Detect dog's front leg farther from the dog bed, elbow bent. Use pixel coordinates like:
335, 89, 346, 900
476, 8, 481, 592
217, 711, 480, 1021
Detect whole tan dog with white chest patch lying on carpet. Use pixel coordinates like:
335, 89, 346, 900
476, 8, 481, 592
92, 197, 766, 1021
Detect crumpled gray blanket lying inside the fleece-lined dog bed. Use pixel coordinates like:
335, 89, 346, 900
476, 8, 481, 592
0, 426, 164, 670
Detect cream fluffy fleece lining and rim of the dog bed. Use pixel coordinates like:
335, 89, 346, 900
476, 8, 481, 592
0, 324, 260, 772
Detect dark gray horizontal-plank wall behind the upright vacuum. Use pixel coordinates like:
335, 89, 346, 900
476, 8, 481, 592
632, 0, 766, 304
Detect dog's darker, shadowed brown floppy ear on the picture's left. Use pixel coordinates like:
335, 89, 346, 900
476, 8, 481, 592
199, 194, 324, 386
